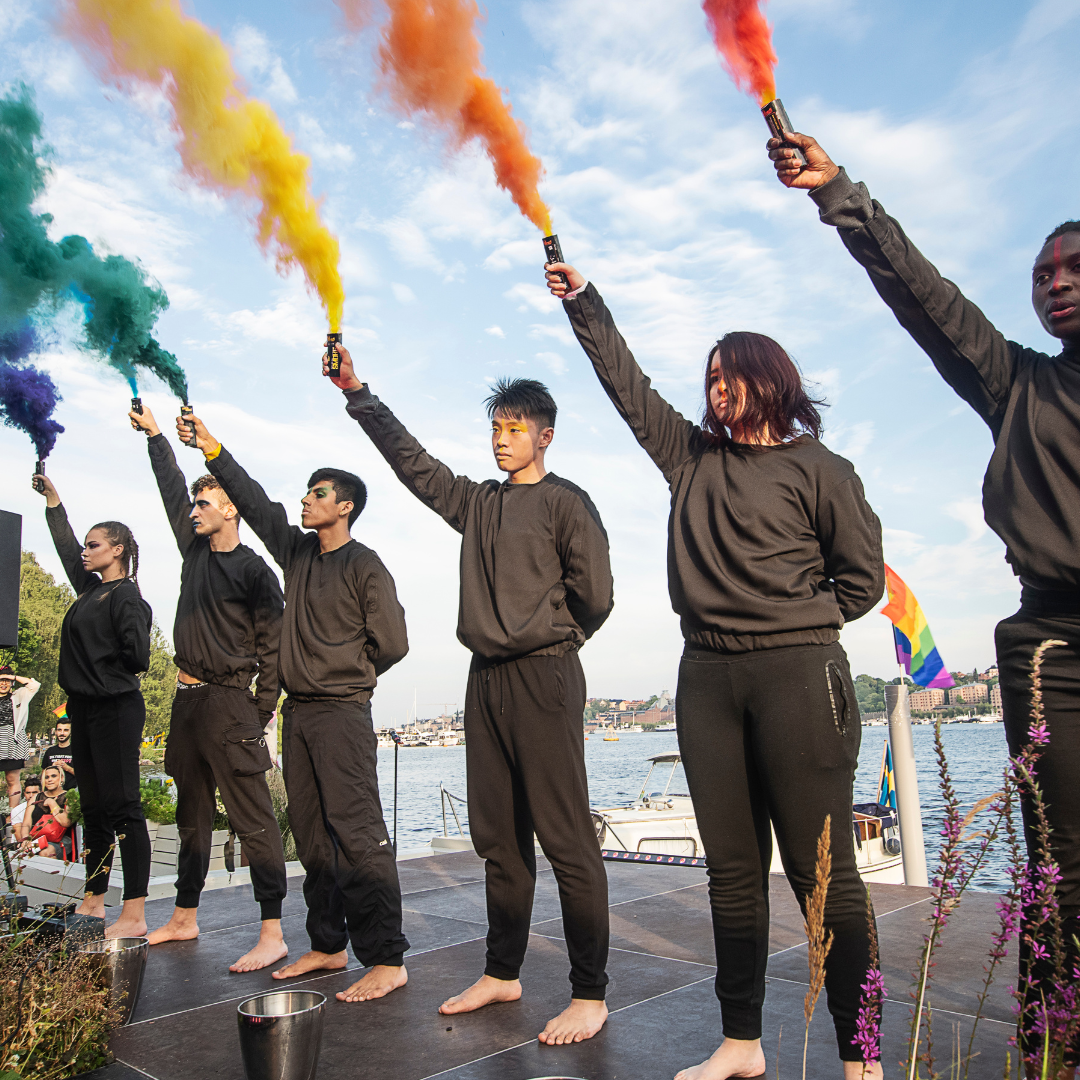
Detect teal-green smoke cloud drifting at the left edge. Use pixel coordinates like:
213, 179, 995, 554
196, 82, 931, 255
0, 86, 188, 401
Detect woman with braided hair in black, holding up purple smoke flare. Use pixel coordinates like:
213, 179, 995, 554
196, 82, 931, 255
33, 475, 152, 937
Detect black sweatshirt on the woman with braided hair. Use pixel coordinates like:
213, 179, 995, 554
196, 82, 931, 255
45, 505, 153, 698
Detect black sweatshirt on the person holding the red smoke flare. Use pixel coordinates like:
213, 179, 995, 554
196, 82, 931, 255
810, 168, 1080, 590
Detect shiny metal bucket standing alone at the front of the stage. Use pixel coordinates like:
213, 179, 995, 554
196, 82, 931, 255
237, 990, 326, 1080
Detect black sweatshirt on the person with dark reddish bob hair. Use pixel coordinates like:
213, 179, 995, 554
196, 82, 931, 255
563, 284, 885, 652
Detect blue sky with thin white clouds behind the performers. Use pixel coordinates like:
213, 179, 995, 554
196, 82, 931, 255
0, 0, 1080, 724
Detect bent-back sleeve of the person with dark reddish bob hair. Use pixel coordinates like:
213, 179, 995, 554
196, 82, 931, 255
815, 476, 885, 623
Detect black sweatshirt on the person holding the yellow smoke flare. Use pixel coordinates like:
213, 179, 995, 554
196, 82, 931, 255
346, 387, 615, 660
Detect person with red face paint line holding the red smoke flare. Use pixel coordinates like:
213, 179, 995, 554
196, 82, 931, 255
767, 134, 1080, 1077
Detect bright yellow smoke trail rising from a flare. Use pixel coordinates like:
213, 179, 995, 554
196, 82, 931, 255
64, 0, 345, 330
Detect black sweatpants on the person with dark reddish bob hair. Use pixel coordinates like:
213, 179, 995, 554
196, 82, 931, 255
676, 645, 869, 1062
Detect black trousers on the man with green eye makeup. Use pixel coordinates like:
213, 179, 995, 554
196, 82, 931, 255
282, 699, 408, 968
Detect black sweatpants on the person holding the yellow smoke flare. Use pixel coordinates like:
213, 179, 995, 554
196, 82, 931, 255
465, 652, 608, 1001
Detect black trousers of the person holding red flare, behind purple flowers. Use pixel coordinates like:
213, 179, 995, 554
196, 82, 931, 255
995, 589, 1080, 1065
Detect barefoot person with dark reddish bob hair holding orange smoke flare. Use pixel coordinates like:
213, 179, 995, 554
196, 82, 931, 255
548, 264, 885, 1080
